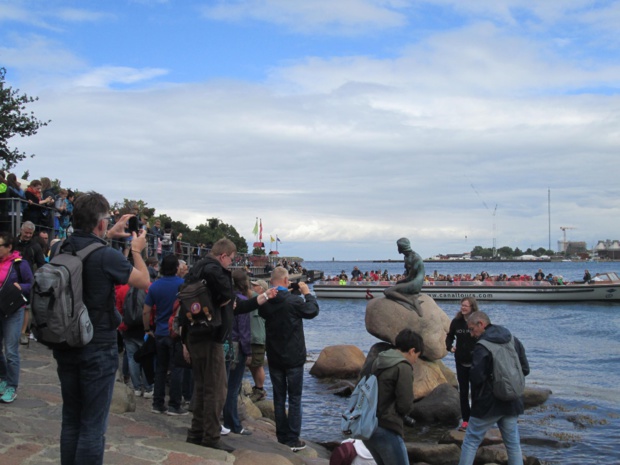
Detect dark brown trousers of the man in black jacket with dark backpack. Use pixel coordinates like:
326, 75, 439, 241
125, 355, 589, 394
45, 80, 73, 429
188, 340, 227, 444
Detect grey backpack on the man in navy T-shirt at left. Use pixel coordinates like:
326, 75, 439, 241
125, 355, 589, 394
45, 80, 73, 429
31, 243, 104, 349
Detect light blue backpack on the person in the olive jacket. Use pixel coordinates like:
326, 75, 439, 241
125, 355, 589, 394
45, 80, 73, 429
340, 375, 379, 439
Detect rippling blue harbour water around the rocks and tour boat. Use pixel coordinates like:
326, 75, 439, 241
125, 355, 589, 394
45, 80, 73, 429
260, 262, 620, 465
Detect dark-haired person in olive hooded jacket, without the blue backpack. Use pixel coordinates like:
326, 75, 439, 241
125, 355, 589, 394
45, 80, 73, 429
364, 329, 424, 465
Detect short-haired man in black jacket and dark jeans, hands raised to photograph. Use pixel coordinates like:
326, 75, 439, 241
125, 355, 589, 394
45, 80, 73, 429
258, 267, 319, 452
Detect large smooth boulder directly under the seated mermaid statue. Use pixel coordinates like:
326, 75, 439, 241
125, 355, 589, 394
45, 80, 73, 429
366, 294, 450, 360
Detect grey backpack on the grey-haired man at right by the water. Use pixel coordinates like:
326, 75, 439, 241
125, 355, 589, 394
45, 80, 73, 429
478, 336, 525, 401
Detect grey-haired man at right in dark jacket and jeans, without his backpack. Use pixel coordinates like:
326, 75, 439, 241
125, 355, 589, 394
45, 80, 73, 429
459, 312, 530, 465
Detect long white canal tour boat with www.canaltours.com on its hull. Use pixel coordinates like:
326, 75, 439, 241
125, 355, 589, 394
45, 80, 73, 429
313, 272, 620, 302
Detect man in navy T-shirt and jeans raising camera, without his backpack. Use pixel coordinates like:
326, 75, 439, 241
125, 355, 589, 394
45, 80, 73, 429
54, 192, 149, 465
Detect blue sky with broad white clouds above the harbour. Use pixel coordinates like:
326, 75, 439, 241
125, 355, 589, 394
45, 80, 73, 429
0, 0, 620, 260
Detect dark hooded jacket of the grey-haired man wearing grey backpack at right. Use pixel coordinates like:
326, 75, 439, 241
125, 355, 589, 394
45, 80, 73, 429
469, 325, 530, 418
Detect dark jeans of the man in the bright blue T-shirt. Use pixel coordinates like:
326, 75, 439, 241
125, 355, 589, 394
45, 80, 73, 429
153, 336, 183, 410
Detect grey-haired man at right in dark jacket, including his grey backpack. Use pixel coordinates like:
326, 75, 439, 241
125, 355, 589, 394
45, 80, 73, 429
459, 311, 530, 465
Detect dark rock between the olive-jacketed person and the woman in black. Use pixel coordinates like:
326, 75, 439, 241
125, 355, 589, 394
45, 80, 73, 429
411, 383, 461, 427
